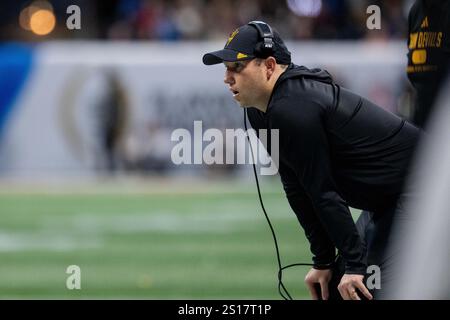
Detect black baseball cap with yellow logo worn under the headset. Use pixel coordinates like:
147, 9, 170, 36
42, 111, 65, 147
203, 24, 291, 65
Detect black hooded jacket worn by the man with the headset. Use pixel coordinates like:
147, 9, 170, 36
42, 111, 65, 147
248, 64, 420, 274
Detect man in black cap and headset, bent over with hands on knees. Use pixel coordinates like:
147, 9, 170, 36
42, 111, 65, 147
203, 21, 420, 300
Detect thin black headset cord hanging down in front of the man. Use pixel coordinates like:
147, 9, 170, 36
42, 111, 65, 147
244, 109, 313, 300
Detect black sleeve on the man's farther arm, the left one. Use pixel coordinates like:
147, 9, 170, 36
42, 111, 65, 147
278, 162, 335, 269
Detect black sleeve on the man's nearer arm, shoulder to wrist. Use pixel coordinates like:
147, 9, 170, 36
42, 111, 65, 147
271, 97, 366, 274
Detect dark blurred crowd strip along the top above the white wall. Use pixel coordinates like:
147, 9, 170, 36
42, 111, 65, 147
0, 0, 411, 41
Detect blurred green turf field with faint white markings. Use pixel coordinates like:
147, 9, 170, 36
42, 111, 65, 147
0, 181, 358, 299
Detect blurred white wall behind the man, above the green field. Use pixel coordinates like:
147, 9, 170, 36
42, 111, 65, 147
0, 42, 406, 177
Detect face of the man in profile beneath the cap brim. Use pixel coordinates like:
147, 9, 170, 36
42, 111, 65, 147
224, 59, 265, 107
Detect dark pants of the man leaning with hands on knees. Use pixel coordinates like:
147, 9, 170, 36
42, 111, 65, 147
329, 198, 406, 300
